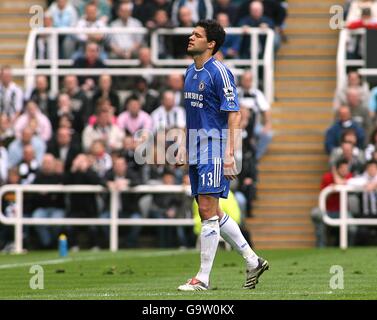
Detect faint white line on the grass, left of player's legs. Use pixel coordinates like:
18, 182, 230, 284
0, 250, 196, 270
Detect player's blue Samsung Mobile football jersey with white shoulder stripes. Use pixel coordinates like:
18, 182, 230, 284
184, 57, 239, 164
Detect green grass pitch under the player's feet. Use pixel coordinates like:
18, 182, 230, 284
0, 248, 377, 300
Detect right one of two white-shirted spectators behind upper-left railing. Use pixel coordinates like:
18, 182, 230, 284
110, 2, 144, 59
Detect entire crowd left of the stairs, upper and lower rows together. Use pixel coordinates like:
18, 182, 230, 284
0, 0, 286, 249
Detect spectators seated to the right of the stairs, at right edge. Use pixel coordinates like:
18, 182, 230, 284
312, 0, 377, 247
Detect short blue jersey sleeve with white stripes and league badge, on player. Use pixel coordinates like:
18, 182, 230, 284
214, 61, 240, 111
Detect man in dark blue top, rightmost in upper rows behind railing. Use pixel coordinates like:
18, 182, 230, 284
238, 1, 280, 59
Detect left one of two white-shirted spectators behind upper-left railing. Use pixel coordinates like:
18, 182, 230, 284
72, 2, 107, 59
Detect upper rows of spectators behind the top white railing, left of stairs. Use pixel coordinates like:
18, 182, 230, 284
37, 0, 287, 60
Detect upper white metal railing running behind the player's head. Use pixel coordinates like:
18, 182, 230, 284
13, 27, 274, 102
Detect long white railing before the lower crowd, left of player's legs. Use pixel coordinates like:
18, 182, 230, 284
0, 184, 194, 253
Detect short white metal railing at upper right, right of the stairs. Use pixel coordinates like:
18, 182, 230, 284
336, 28, 365, 88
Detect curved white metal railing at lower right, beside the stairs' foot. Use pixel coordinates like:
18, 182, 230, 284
319, 185, 377, 249
